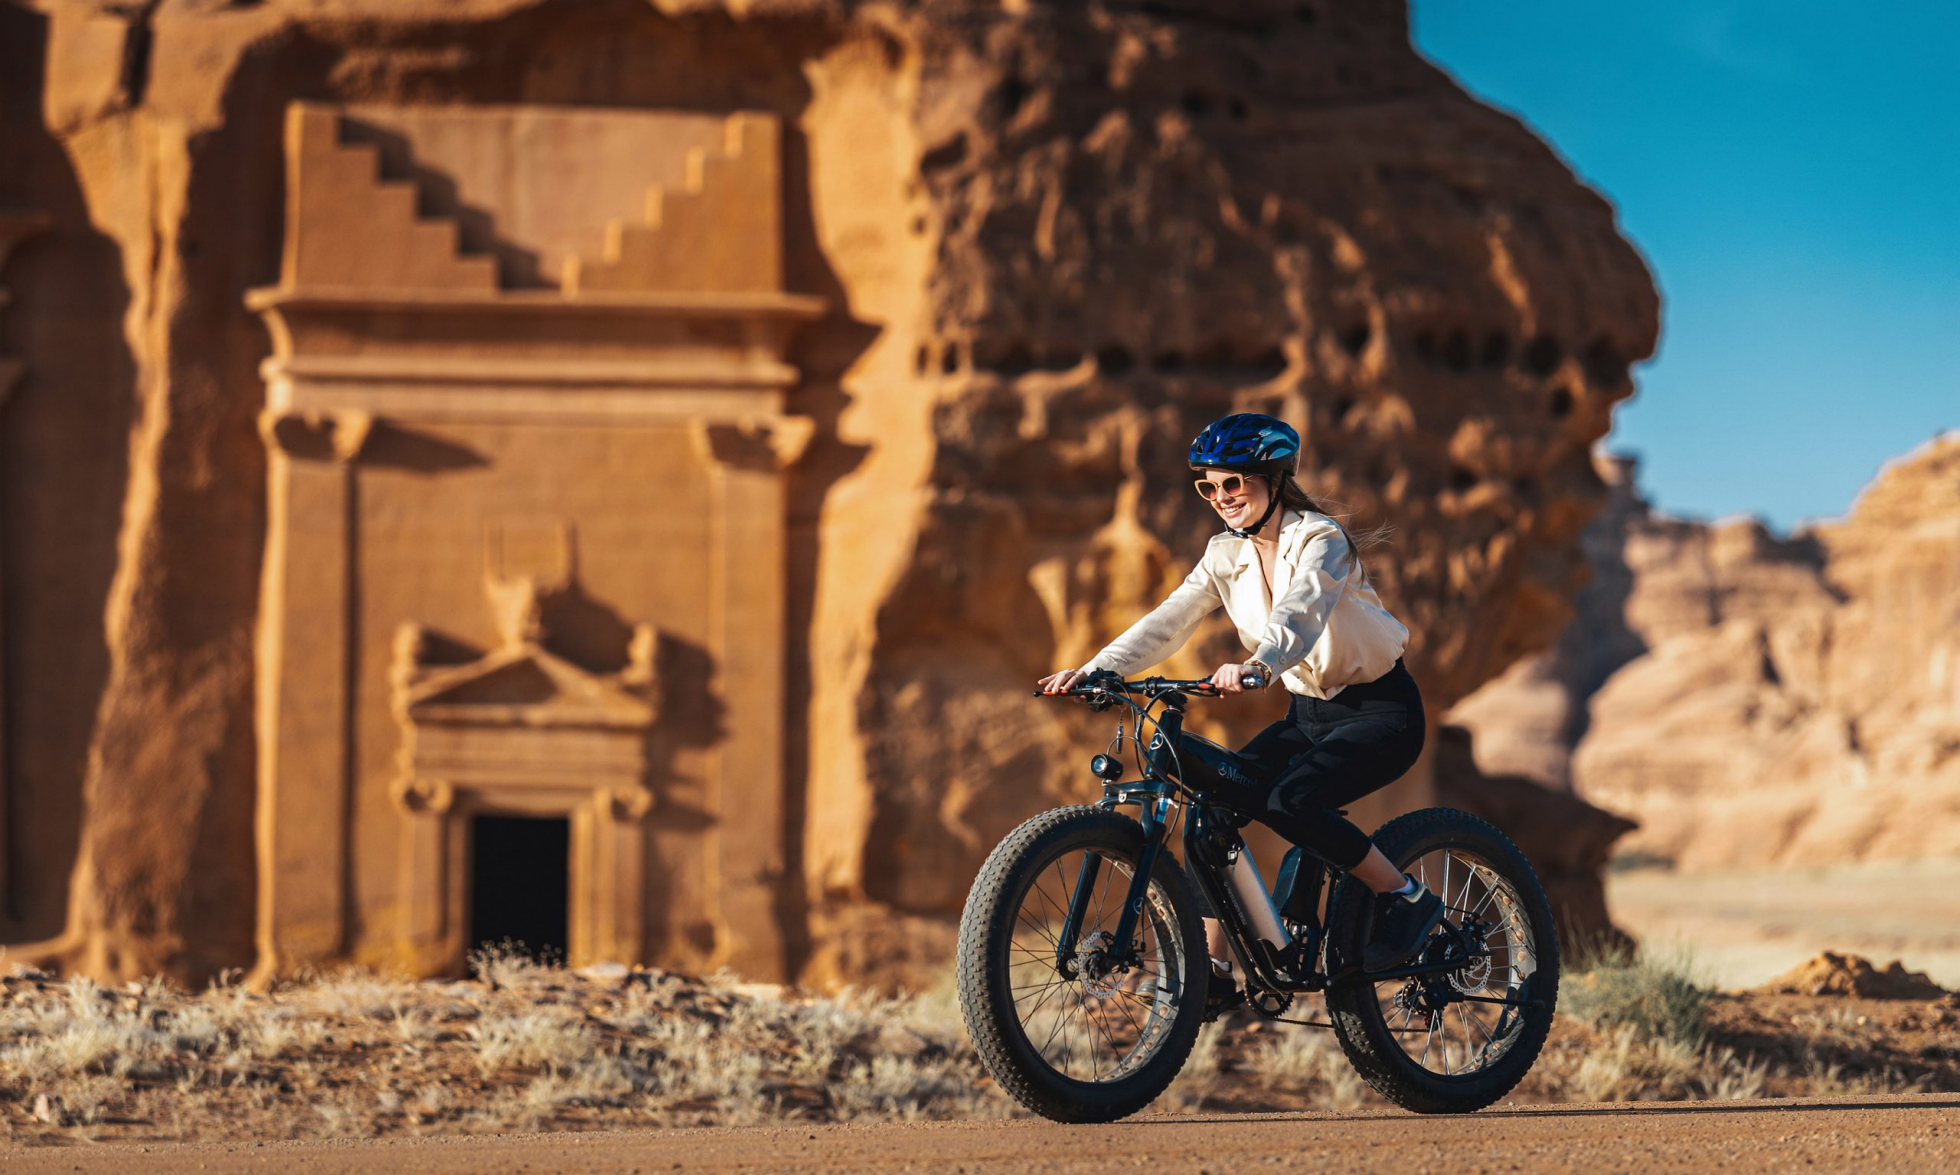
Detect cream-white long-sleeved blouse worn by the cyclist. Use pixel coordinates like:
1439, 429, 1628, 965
1082, 510, 1409, 698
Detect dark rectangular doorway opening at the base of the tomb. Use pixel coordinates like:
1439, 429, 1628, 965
466, 816, 572, 963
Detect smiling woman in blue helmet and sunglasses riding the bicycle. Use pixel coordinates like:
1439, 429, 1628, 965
1041, 412, 1443, 985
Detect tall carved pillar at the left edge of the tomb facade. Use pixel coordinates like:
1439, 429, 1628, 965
257, 412, 372, 973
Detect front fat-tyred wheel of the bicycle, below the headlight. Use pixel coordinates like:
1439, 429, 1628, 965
956, 806, 1209, 1122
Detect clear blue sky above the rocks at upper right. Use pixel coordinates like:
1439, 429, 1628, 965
1411, 0, 1960, 530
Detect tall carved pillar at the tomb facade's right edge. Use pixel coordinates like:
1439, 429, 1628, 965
694, 418, 811, 975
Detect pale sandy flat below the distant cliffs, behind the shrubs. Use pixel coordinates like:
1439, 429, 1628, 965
1607, 857, 1960, 989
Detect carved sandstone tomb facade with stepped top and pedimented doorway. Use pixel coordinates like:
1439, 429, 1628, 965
249, 104, 821, 975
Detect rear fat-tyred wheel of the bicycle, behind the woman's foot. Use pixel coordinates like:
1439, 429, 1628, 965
1327, 808, 1558, 1114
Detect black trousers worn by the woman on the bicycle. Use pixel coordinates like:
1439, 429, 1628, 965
1239, 659, 1423, 869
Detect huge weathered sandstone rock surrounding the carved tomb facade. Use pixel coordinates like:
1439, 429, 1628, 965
0, 0, 1656, 979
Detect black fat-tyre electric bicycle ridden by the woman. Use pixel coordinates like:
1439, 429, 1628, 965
956, 673, 1558, 1122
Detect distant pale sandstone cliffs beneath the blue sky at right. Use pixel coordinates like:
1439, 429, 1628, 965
1456, 434, 1960, 867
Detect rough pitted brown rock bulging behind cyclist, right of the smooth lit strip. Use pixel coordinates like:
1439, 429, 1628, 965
813, 4, 1654, 945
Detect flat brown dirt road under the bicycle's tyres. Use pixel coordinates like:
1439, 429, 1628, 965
0, 1095, 1960, 1175
